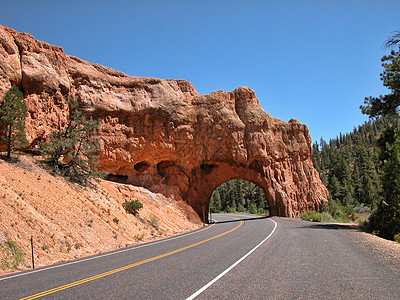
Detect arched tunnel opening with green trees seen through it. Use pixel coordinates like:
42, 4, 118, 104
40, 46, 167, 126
209, 179, 269, 216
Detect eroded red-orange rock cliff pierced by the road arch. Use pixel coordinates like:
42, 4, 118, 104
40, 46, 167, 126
0, 26, 327, 217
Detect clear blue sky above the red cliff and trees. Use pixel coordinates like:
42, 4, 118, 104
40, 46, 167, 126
0, 0, 400, 141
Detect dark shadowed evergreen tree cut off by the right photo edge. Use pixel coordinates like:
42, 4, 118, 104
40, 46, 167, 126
361, 31, 400, 239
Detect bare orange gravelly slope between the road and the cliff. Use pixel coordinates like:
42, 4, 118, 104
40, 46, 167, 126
0, 156, 202, 275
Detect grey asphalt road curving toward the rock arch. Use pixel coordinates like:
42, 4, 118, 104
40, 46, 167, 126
0, 215, 400, 299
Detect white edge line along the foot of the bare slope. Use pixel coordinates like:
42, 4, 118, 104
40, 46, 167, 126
0, 222, 217, 281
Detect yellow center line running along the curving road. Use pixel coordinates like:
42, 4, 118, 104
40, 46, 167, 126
20, 218, 244, 300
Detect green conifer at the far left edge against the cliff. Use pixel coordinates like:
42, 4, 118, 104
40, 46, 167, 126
0, 85, 27, 158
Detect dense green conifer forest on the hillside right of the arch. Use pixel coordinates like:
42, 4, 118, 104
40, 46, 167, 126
312, 115, 399, 219
